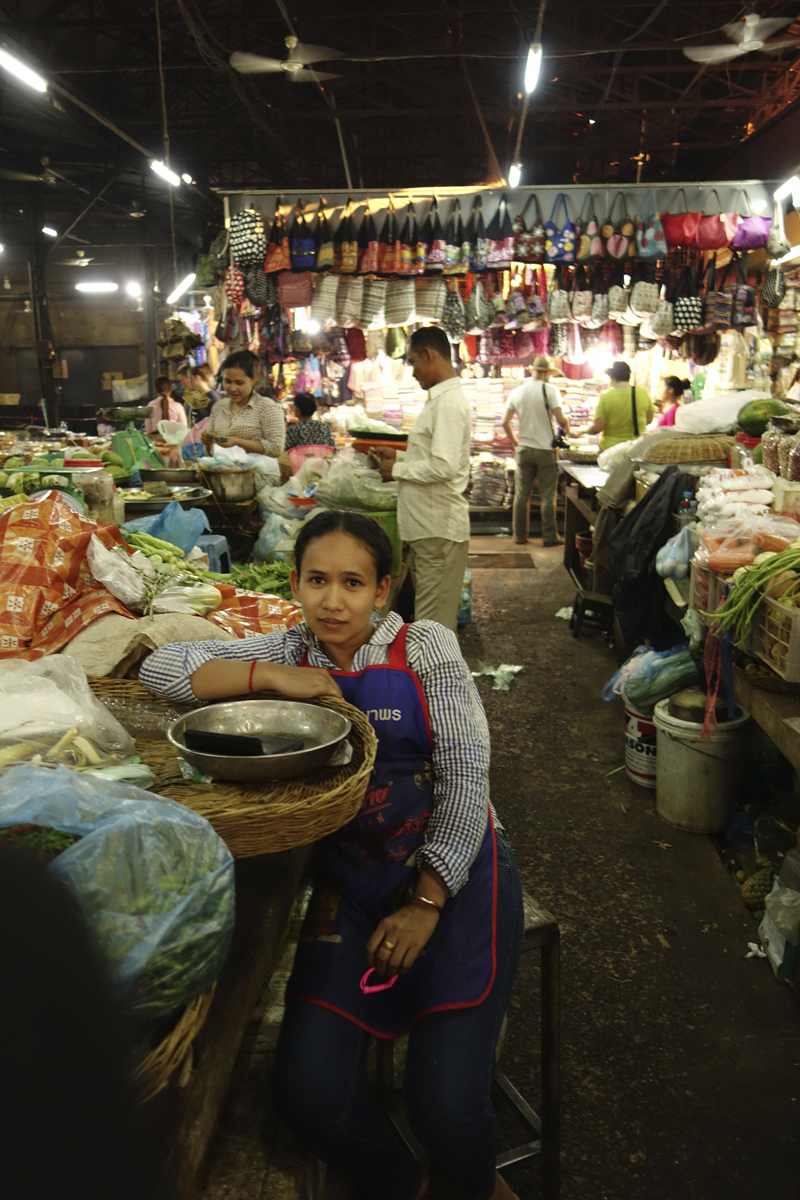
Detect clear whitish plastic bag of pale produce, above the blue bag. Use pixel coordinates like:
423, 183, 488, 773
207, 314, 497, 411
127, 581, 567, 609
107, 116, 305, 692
0, 655, 133, 770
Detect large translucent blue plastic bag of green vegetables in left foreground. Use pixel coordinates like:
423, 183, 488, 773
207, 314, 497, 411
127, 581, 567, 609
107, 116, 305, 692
0, 767, 234, 1024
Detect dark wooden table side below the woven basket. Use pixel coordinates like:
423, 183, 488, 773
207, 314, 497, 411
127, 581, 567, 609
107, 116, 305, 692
137, 846, 311, 1200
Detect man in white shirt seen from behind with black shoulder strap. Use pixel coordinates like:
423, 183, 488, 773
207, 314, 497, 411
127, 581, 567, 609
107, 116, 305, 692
503, 354, 570, 546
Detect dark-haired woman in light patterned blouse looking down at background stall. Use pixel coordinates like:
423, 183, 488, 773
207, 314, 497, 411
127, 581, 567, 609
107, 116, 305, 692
201, 350, 285, 458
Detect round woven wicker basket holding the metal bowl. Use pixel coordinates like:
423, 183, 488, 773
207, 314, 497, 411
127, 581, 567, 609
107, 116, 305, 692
90, 679, 378, 858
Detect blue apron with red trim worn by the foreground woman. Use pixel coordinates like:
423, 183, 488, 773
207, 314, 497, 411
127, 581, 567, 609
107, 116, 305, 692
287, 625, 497, 1038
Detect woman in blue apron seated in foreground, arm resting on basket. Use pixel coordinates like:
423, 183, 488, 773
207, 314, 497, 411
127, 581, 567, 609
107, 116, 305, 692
139, 512, 523, 1200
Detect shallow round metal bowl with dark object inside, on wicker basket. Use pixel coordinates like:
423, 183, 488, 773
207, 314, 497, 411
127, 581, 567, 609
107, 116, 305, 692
167, 700, 351, 784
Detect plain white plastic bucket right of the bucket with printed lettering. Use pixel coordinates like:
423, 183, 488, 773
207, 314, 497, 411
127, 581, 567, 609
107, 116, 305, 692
652, 700, 750, 833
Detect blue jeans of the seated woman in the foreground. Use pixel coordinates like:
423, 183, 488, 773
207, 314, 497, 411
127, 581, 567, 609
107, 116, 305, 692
275, 834, 523, 1200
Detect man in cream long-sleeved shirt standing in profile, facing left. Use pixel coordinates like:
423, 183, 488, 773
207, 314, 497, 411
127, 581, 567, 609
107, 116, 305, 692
381, 325, 473, 630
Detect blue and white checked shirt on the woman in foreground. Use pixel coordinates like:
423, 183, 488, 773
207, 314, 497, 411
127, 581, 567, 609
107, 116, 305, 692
139, 613, 497, 895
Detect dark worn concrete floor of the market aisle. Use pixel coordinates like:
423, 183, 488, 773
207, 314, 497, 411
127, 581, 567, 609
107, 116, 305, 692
204, 538, 800, 1200
